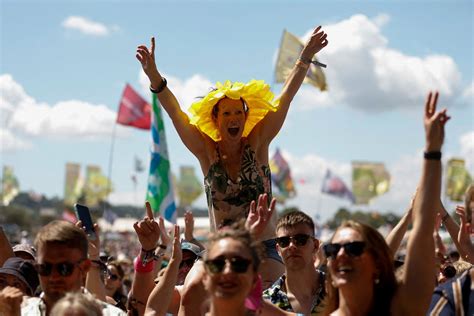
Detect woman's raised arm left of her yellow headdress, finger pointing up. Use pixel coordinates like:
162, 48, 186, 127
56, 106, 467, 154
136, 37, 206, 161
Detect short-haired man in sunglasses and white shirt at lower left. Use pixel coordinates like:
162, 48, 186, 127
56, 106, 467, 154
21, 220, 125, 315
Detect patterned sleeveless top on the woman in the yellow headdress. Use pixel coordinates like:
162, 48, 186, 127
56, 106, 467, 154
204, 144, 271, 231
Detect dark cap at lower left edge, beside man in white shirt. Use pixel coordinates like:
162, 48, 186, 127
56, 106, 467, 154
0, 257, 39, 295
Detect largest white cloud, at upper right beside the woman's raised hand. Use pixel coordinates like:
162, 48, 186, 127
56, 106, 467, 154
295, 14, 461, 112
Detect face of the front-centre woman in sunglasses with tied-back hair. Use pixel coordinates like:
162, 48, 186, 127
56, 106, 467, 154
204, 238, 257, 303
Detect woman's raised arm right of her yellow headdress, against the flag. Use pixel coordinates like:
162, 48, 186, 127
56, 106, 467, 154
256, 26, 328, 145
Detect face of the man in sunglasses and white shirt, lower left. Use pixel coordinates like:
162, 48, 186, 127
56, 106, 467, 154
37, 244, 90, 302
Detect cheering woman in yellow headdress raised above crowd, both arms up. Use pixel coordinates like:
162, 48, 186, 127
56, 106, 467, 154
136, 27, 328, 282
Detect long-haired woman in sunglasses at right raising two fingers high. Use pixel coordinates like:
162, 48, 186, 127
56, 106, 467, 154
323, 92, 449, 315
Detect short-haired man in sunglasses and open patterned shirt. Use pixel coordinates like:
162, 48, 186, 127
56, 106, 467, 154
263, 211, 325, 315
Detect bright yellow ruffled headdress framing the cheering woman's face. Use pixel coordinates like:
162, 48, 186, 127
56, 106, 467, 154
189, 79, 277, 142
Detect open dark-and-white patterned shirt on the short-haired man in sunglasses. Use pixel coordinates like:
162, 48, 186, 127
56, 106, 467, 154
263, 269, 326, 315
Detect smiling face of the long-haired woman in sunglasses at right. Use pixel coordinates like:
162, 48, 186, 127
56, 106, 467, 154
328, 227, 377, 287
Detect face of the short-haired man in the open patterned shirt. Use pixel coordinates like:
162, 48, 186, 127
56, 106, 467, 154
277, 223, 319, 270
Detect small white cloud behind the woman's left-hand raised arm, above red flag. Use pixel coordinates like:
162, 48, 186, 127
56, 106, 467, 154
138, 70, 214, 113
